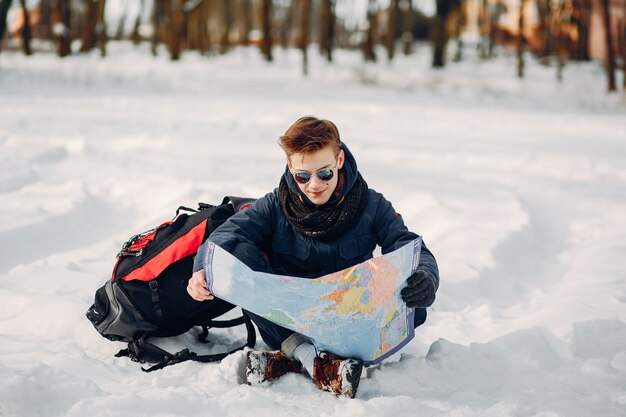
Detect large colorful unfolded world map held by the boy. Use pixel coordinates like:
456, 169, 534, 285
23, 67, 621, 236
204, 238, 422, 365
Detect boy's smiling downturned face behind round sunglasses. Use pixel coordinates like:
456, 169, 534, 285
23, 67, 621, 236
287, 146, 345, 206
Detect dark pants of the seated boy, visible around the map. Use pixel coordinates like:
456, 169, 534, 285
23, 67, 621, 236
232, 243, 426, 350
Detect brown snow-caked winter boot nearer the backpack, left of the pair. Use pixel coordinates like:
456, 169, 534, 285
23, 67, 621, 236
246, 350, 302, 385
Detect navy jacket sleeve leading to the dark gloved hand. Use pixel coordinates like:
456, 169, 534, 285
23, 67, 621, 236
374, 195, 439, 289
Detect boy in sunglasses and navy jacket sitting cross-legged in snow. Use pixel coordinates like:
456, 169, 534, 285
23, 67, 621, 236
187, 116, 439, 398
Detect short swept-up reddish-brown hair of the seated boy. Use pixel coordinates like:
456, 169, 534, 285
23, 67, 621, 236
278, 116, 341, 157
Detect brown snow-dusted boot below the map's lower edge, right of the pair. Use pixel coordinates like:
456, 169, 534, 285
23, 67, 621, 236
313, 352, 363, 398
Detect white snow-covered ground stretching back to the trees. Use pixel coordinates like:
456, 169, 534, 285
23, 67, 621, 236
0, 45, 626, 417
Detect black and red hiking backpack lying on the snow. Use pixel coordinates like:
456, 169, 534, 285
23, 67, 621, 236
86, 197, 256, 372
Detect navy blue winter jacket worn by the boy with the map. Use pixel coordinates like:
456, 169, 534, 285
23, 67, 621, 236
194, 145, 439, 288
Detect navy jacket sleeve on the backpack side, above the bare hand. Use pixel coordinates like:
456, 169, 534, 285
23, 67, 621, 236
193, 193, 276, 272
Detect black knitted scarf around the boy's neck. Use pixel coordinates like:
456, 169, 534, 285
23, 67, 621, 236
279, 173, 369, 241
